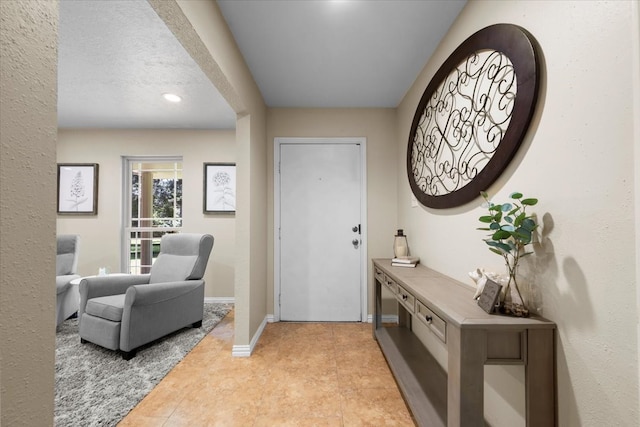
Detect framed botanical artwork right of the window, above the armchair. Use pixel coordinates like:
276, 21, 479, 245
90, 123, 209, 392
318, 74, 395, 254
203, 163, 236, 213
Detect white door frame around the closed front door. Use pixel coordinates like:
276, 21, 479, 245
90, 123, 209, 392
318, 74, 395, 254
273, 137, 369, 322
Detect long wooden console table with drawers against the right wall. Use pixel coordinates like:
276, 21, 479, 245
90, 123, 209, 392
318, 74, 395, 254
373, 259, 558, 427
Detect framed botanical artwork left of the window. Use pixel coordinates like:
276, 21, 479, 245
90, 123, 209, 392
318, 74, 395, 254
58, 163, 98, 215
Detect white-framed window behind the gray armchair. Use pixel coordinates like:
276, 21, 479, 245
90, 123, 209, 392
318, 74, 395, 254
122, 157, 182, 274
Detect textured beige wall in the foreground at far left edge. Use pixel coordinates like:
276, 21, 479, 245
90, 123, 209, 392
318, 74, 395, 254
0, 0, 58, 426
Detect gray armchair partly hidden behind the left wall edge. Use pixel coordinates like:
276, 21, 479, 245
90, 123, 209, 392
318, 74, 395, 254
56, 234, 80, 328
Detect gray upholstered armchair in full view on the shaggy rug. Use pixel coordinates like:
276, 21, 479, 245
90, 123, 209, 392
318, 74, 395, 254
78, 233, 213, 360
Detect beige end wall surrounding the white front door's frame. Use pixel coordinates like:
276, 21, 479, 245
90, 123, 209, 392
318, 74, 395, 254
267, 108, 397, 314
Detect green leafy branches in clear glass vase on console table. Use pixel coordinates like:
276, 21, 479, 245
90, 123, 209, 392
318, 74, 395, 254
478, 191, 538, 317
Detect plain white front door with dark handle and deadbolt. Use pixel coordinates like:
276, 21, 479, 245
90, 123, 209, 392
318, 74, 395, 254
279, 139, 363, 321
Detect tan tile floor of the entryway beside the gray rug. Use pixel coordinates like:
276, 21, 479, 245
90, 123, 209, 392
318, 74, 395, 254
119, 311, 414, 427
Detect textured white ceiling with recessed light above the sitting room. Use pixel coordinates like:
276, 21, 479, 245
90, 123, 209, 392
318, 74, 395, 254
58, 0, 236, 129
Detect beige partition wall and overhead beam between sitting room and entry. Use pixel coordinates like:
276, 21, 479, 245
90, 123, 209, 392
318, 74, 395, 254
170, 0, 267, 348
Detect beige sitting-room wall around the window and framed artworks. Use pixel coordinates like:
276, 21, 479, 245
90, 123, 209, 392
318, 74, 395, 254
57, 129, 236, 297
